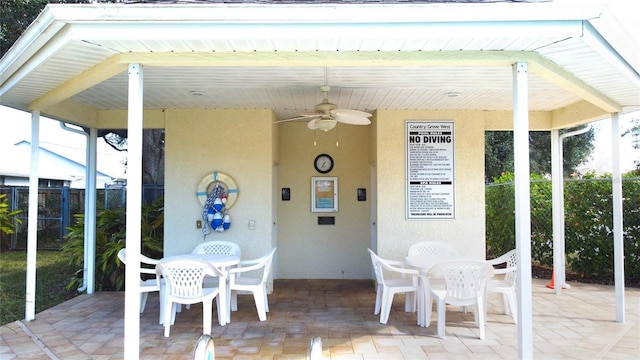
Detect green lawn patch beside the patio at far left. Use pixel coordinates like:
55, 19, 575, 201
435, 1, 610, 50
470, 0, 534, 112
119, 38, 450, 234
0, 250, 78, 325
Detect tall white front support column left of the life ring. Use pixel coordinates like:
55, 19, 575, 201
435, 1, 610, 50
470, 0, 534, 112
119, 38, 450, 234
124, 64, 143, 360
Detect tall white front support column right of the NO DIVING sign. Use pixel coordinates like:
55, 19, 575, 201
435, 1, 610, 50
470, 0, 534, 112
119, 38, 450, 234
513, 62, 533, 359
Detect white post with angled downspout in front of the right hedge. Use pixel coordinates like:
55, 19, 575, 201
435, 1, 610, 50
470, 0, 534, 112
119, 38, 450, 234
551, 127, 591, 295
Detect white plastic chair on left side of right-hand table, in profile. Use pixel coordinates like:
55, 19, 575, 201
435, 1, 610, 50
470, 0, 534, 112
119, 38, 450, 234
367, 249, 418, 324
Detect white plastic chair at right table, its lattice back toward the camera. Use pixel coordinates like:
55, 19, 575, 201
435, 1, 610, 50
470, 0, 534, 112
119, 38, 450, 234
426, 261, 493, 339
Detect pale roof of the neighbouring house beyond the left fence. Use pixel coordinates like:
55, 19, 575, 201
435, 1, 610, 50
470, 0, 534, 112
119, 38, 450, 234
0, 141, 113, 182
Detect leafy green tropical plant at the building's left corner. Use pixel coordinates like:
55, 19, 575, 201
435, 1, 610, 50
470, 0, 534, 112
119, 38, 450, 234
62, 198, 164, 291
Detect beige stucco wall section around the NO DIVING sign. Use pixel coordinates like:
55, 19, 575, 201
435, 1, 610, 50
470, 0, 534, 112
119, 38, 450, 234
376, 110, 485, 260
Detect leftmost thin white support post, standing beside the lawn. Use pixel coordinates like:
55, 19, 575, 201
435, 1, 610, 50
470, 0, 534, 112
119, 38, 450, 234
24, 111, 40, 321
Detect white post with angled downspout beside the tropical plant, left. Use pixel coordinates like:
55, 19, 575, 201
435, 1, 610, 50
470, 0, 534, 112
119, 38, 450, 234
60, 122, 98, 294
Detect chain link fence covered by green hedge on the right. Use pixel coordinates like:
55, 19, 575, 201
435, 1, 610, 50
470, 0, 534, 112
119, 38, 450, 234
485, 177, 640, 285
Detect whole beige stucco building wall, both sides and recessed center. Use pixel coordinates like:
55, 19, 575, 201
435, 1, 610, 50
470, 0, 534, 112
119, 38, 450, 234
159, 110, 485, 279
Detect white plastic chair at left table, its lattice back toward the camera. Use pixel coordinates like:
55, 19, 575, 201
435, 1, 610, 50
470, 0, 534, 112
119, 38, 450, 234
156, 257, 226, 337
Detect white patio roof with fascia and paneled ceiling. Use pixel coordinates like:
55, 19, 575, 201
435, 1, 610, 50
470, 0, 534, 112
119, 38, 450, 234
0, 0, 640, 128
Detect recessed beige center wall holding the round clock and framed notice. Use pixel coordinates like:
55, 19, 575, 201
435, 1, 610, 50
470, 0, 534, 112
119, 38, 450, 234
277, 122, 371, 279
